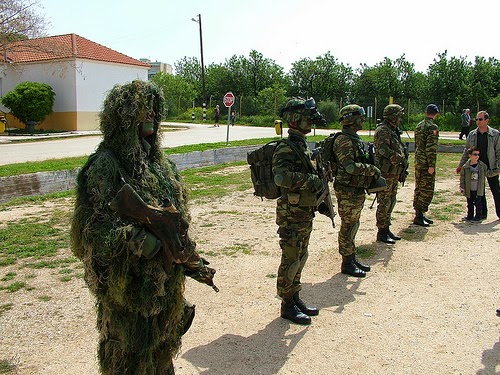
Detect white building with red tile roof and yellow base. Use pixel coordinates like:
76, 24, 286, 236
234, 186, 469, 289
0, 34, 150, 130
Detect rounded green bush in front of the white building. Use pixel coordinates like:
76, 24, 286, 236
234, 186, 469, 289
1, 82, 56, 130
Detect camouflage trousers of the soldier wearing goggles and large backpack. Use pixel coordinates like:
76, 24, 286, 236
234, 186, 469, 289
276, 199, 314, 300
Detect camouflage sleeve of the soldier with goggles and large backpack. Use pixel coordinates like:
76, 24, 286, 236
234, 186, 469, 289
273, 143, 310, 189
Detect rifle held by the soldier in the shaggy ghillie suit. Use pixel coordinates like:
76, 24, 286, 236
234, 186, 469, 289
109, 184, 219, 292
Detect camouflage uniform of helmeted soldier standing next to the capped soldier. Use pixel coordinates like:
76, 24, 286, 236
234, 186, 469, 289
373, 113, 408, 229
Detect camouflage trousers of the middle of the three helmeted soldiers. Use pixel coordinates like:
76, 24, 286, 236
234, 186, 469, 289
335, 189, 365, 256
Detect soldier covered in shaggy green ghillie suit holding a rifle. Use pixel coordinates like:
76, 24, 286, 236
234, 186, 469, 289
71, 81, 215, 375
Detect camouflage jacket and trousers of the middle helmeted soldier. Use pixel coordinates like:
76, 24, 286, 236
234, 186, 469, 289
333, 126, 380, 256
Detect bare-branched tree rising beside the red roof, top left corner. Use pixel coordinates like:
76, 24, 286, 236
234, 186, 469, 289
0, 0, 49, 62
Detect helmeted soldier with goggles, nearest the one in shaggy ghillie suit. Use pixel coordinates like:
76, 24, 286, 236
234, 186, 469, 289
272, 98, 324, 324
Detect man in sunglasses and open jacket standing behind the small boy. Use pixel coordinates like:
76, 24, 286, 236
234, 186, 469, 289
456, 111, 500, 220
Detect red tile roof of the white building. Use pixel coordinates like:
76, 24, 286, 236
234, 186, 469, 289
2, 34, 150, 67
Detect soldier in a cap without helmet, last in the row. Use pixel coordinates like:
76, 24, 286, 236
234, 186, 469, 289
413, 104, 439, 227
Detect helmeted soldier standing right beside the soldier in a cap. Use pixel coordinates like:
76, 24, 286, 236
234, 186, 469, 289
373, 104, 408, 244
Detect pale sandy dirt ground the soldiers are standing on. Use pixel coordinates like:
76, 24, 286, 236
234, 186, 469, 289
0, 174, 500, 375
